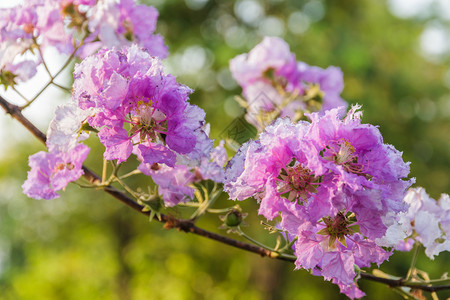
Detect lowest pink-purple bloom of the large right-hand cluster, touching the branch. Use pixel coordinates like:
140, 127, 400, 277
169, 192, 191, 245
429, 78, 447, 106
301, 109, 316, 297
279, 212, 392, 299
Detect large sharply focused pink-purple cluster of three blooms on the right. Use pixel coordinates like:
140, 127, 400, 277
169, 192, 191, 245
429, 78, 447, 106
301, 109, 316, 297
225, 106, 413, 298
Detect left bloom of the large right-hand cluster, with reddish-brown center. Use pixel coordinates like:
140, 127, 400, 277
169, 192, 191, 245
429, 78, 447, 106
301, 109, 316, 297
225, 119, 335, 222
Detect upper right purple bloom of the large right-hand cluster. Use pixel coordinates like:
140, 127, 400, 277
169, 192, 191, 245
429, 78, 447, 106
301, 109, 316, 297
308, 106, 414, 238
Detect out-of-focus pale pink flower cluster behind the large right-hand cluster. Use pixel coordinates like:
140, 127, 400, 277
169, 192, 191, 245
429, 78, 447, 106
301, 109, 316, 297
230, 37, 347, 131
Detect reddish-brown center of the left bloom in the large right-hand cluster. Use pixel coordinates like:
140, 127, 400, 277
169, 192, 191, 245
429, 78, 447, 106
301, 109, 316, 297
277, 158, 322, 204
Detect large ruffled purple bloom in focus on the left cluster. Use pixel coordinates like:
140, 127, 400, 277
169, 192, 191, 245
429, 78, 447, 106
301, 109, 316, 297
73, 45, 205, 167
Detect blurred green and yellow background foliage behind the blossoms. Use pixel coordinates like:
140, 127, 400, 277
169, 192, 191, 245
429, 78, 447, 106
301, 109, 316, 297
0, 0, 450, 300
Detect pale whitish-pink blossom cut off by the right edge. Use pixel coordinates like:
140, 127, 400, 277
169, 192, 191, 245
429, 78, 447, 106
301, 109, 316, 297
377, 187, 450, 259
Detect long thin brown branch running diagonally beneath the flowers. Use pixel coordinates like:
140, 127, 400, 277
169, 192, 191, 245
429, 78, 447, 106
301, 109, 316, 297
0, 96, 450, 292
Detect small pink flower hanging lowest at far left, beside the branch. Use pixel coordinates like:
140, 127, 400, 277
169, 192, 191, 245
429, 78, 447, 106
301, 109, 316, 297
22, 144, 89, 200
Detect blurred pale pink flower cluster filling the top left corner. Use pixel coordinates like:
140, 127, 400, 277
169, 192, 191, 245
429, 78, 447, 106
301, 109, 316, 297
0, 0, 167, 86
